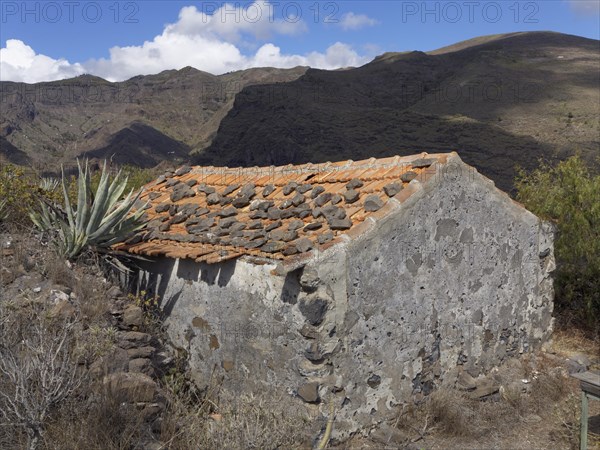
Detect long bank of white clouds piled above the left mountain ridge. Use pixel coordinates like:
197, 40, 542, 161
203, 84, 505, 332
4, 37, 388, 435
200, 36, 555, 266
0, 0, 368, 83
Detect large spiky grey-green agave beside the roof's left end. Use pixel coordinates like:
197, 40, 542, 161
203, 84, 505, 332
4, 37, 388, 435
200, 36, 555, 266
31, 161, 145, 259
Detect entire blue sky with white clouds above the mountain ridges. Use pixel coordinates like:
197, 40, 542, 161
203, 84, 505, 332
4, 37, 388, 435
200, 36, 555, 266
0, 0, 600, 82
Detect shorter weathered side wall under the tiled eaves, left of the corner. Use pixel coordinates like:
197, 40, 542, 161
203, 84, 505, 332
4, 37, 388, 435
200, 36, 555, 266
137, 258, 346, 442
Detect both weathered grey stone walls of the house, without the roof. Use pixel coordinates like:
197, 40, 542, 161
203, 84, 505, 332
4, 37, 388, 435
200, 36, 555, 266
134, 158, 554, 439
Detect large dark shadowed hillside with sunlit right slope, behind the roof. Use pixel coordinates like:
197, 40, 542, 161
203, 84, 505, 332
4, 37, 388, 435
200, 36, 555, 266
194, 32, 600, 190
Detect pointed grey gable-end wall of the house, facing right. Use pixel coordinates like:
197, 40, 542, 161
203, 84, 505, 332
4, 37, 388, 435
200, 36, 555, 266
324, 156, 554, 436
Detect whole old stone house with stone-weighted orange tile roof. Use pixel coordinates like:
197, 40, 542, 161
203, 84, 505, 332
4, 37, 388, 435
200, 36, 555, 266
122, 153, 554, 437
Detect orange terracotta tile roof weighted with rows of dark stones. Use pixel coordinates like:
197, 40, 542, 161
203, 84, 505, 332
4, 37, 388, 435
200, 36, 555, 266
116, 153, 447, 264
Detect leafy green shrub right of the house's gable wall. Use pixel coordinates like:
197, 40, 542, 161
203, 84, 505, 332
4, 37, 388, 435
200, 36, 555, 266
515, 156, 600, 326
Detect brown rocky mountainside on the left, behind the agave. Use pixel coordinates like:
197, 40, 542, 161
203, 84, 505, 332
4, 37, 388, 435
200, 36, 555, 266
0, 67, 306, 171
